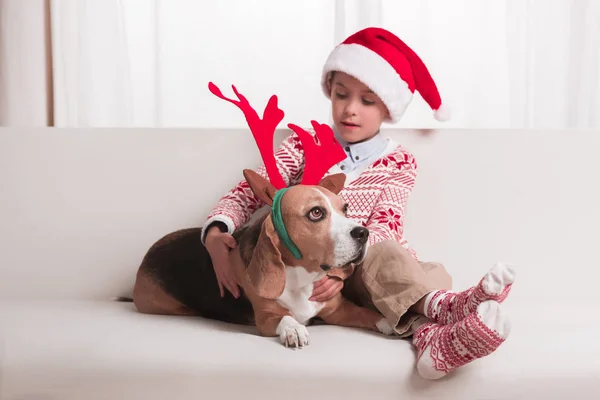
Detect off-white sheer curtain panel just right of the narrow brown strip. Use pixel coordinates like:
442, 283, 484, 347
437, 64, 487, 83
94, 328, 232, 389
50, 0, 134, 126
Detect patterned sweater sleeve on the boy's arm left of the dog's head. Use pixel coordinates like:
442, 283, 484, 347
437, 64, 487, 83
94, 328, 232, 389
201, 132, 304, 244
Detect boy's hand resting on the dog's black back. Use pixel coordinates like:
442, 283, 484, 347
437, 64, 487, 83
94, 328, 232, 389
206, 227, 240, 299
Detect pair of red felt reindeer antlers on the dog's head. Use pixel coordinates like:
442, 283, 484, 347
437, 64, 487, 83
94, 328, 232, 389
208, 82, 346, 190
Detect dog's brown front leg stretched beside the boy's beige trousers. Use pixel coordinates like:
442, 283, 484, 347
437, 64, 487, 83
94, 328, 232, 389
319, 295, 394, 335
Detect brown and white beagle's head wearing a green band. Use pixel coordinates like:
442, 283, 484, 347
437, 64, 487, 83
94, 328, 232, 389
244, 170, 369, 299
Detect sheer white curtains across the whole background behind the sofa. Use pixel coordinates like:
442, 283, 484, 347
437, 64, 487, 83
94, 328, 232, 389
0, 0, 600, 129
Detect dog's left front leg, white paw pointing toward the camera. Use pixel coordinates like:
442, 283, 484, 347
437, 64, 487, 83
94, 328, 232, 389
256, 312, 310, 348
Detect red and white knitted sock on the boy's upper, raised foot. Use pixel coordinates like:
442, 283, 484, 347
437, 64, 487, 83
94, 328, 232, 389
425, 263, 515, 325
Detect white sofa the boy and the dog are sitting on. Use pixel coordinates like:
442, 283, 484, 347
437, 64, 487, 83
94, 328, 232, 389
0, 129, 600, 400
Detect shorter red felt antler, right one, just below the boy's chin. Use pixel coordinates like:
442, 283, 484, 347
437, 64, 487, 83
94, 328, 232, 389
288, 121, 346, 185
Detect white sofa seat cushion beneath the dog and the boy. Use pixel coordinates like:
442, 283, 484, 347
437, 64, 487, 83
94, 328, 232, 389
0, 301, 600, 400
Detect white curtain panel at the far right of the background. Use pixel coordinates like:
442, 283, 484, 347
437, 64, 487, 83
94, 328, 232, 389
507, 0, 600, 129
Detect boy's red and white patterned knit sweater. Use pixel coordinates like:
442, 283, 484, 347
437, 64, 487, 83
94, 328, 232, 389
202, 131, 418, 259
